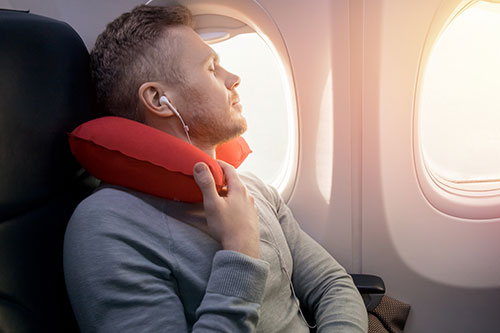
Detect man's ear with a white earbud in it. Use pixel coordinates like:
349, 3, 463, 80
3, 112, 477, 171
138, 82, 174, 118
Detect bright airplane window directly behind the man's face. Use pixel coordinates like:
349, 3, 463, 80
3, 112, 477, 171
211, 32, 297, 190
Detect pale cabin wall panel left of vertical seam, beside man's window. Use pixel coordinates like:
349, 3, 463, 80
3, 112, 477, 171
259, 0, 360, 272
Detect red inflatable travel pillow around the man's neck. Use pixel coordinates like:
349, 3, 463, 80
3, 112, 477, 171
68, 117, 252, 202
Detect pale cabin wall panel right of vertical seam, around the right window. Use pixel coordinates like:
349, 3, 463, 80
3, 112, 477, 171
362, 0, 500, 333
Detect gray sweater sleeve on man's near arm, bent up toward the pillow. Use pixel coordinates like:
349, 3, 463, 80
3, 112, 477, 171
64, 189, 269, 333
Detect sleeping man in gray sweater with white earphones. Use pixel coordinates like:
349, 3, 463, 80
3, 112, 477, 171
64, 6, 367, 333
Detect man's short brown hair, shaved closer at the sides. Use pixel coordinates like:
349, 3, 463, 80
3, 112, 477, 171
90, 5, 193, 122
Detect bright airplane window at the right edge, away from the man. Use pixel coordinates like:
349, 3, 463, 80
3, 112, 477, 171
418, 1, 500, 192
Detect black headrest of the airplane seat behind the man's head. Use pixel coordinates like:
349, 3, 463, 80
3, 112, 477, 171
0, 10, 93, 221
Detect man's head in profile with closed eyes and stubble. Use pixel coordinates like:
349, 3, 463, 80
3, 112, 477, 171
91, 5, 246, 146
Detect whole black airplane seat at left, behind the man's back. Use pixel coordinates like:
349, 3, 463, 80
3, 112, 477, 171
0, 10, 96, 333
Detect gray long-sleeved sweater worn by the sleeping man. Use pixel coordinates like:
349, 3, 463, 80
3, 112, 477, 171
64, 175, 368, 333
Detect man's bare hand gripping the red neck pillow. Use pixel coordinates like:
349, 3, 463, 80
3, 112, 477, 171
193, 161, 260, 258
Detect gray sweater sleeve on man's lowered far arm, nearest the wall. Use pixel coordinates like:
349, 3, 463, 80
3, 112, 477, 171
271, 189, 368, 333
